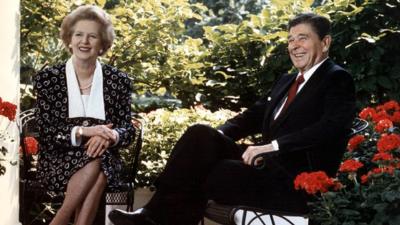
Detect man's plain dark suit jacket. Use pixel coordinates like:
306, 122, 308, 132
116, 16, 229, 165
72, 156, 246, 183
219, 59, 355, 179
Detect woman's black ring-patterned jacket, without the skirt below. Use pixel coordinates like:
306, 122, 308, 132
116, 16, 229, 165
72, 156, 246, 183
33, 64, 135, 151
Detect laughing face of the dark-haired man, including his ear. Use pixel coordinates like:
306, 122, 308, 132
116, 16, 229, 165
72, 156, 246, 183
288, 23, 331, 73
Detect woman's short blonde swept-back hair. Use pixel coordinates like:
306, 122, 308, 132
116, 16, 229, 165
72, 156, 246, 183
60, 5, 115, 55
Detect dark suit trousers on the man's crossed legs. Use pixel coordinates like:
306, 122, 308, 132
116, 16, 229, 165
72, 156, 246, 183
145, 125, 308, 225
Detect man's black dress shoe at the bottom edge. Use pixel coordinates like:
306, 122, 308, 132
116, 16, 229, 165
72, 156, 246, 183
108, 208, 159, 225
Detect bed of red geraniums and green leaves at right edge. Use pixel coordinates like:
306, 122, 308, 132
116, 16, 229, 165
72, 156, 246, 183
294, 101, 400, 225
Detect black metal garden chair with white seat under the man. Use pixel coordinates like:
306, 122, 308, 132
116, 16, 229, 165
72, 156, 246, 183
201, 118, 368, 225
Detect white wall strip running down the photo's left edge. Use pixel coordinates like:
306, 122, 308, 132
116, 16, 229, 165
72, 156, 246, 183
0, 0, 20, 225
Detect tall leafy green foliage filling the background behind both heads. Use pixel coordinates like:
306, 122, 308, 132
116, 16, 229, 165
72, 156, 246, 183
20, 0, 400, 111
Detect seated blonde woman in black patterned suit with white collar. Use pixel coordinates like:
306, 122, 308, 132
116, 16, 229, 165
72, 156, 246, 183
34, 5, 134, 225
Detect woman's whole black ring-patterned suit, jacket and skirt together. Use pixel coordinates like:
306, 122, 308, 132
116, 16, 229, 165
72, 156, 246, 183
33, 64, 135, 192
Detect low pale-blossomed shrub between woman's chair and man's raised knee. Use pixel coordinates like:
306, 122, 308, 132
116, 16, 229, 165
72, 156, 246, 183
137, 107, 236, 186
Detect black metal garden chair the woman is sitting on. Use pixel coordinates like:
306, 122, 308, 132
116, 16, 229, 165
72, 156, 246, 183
19, 109, 143, 225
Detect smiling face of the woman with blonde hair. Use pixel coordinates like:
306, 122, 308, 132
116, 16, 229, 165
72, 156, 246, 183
70, 20, 102, 61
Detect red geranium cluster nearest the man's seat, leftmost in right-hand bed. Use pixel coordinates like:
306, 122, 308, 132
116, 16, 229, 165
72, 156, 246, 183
294, 171, 341, 194
